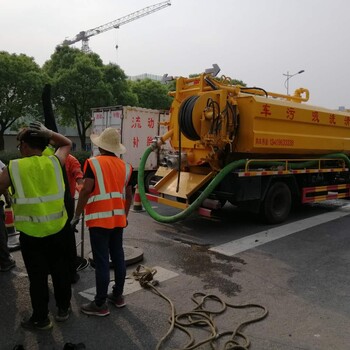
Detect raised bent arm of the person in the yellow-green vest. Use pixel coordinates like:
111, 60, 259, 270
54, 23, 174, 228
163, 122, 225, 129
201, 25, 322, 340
29, 122, 72, 166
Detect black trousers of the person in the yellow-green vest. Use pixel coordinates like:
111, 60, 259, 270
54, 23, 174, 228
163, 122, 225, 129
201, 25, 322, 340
20, 226, 72, 321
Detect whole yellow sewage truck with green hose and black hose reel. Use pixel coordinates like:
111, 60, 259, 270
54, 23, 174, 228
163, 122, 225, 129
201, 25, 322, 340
138, 65, 350, 223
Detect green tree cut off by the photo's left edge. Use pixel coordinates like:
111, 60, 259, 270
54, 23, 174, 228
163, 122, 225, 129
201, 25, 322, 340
0, 51, 44, 150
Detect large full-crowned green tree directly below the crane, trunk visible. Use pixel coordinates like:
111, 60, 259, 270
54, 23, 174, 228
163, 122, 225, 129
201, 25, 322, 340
43, 46, 107, 149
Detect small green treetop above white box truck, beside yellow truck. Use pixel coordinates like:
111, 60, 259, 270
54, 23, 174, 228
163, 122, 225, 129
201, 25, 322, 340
131, 79, 172, 109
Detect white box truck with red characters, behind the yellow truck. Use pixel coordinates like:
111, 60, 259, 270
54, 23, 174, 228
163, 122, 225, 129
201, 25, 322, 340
91, 106, 170, 189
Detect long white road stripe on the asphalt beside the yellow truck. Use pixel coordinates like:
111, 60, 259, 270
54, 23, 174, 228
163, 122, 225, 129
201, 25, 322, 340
209, 204, 350, 256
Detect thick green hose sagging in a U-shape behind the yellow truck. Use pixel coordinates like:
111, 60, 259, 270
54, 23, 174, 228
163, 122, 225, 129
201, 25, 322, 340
137, 146, 246, 223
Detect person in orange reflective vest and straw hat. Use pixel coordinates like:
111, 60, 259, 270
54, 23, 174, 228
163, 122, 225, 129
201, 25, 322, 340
72, 128, 132, 316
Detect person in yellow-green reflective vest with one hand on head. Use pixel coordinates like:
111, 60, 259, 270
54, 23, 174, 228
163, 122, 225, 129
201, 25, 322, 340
0, 122, 71, 330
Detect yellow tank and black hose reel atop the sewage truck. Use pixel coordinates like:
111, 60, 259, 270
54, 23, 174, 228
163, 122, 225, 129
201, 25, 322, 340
165, 68, 350, 170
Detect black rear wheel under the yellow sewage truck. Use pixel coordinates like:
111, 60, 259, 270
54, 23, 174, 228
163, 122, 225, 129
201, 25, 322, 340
261, 182, 292, 224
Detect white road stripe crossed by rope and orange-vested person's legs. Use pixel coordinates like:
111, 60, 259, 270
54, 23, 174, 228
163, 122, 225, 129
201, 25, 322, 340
79, 266, 178, 301
